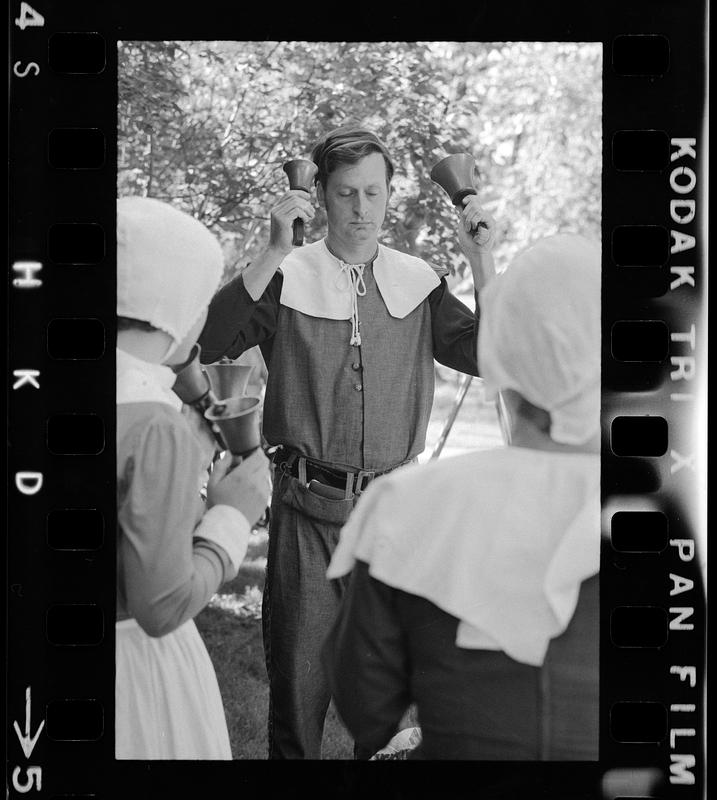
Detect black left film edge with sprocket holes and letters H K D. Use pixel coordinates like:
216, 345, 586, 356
7, 9, 116, 797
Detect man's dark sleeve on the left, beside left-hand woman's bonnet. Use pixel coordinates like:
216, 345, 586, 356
198, 271, 284, 364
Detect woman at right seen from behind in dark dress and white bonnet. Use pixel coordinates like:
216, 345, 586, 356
324, 234, 601, 761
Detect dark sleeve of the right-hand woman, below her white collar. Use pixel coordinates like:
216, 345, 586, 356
322, 561, 411, 753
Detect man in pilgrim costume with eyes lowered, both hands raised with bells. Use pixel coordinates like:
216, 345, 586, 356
199, 128, 494, 759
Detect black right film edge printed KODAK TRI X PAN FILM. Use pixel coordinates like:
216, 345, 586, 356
601, 28, 707, 797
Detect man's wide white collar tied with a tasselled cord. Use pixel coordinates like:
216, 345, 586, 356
281, 239, 440, 319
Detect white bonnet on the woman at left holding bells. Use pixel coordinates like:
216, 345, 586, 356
117, 197, 224, 358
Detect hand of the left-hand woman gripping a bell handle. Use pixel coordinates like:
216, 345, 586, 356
207, 450, 271, 527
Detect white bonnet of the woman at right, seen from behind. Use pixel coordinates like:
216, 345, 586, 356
478, 234, 600, 444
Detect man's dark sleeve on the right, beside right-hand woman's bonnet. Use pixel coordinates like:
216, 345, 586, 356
428, 278, 479, 375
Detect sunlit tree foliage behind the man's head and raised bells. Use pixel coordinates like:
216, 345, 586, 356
118, 41, 602, 284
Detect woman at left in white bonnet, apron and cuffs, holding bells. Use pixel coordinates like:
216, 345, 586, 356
115, 197, 270, 760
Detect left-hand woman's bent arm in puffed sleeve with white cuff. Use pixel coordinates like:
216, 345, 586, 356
118, 417, 250, 636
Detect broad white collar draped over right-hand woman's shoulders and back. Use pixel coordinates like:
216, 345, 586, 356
327, 447, 600, 666
